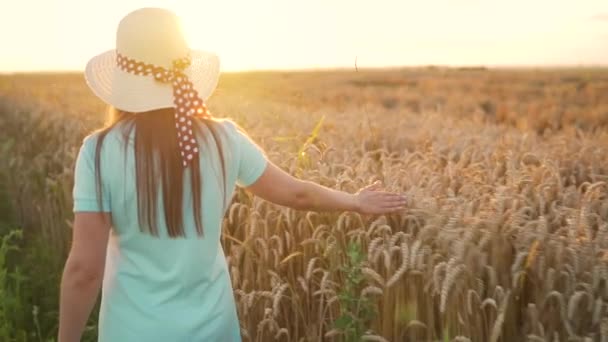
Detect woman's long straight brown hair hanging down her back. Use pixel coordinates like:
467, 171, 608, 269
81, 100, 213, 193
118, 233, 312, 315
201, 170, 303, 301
95, 107, 226, 238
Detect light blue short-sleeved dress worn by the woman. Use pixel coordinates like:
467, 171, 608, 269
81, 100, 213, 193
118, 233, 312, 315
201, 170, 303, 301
73, 120, 267, 342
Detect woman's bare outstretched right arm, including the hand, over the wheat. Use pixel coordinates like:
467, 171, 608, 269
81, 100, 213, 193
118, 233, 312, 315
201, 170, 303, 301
247, 161, 406, 214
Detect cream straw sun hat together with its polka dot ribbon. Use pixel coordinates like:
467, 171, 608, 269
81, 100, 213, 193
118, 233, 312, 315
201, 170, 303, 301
85, 8, 220, 167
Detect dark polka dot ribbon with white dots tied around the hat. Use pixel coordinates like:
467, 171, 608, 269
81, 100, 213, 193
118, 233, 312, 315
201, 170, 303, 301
116, 54, 211, 167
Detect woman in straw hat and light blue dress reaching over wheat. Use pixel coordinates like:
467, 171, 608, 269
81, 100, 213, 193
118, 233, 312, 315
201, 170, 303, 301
59, 9, 405, 342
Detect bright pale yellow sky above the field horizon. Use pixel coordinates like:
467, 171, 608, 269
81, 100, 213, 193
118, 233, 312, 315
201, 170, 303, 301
0, 0, 608, 72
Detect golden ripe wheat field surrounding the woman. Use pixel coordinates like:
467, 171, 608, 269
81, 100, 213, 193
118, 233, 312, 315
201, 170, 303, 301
0, 67, 608, 342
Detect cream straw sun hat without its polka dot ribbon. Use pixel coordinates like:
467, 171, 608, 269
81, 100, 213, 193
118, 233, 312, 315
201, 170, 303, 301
85, 8, 219, 112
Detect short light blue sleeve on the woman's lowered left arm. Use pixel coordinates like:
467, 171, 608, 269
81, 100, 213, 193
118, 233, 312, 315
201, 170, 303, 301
72, 137, 110, 212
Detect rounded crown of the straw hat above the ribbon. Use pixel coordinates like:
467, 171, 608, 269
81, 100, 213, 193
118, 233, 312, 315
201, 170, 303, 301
116, 8, 190, 69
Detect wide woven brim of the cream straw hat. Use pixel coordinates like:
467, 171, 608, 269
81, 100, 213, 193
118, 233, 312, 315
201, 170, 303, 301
84, 50, 220, 113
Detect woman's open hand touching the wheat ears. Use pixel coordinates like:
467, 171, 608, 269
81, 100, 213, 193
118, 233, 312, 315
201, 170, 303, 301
355, 181, 407, 215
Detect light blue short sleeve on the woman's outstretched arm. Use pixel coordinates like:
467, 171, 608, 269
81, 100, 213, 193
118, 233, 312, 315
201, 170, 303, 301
235, 123, 267, 187
